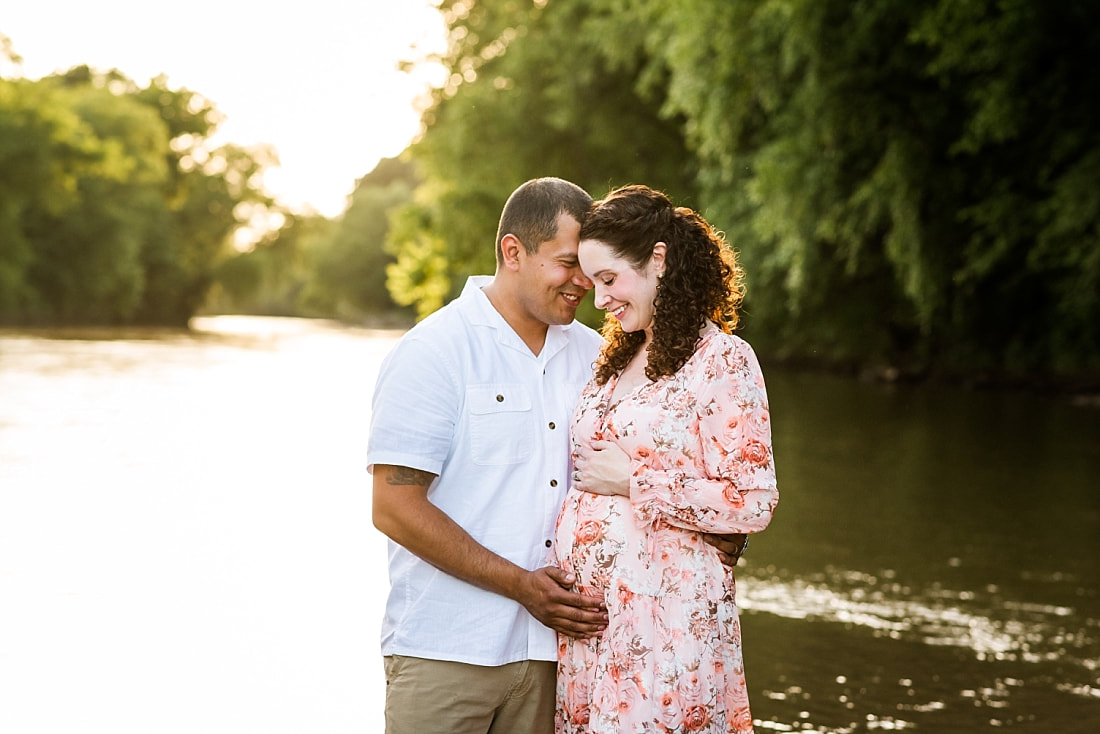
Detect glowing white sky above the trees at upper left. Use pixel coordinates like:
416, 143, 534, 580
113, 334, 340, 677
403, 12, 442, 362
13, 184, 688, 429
0, 0, 443, 217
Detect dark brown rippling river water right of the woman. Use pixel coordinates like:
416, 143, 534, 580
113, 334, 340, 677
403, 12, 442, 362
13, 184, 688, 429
738, 371, 1100, 733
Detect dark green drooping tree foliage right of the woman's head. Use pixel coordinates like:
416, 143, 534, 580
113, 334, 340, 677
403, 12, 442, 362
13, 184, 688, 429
641, 0, 1100, 375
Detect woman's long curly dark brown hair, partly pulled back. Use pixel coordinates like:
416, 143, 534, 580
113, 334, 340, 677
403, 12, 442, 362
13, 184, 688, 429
581, 185, 745, 384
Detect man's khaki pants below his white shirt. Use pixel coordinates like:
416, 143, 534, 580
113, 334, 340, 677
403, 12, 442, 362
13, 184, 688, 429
384, 655, 558, 734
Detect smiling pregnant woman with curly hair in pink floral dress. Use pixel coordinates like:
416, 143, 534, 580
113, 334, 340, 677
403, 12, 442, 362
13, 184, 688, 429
557, 186, 779, 734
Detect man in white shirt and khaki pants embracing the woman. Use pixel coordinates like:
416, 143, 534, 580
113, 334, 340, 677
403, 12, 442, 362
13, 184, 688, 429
367, 178, 736, 734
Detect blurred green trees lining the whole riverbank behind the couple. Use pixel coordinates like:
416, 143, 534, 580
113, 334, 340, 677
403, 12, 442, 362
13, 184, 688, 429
0, 0, 1100, 386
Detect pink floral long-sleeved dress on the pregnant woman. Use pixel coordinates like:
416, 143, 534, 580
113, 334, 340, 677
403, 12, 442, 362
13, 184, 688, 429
556, 330, 779, 734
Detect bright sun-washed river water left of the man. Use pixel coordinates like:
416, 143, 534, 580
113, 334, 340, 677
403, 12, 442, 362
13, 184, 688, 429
0, 318, 404, 734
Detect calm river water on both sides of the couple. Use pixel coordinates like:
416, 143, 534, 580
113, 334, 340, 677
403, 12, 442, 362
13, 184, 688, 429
0, 317, 1100, 734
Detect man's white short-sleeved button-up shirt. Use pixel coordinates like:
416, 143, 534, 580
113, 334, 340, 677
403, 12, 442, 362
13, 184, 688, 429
367, 276, 601, 666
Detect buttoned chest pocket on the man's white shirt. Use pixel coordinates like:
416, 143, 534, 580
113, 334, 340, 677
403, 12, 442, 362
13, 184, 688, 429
466, 383, 535, 465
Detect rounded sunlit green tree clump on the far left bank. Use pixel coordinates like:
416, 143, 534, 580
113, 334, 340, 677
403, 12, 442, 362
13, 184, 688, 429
0, 46, 270, 326
